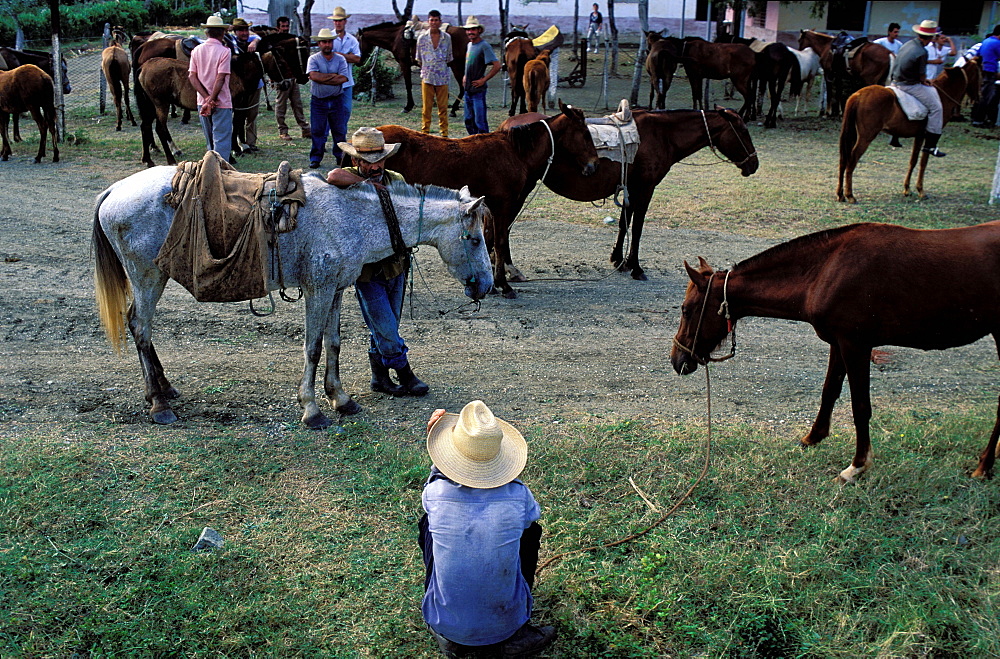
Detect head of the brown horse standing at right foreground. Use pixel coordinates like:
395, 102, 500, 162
670, 256, 733, 375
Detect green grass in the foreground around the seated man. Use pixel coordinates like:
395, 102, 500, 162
0, 406, 1000, 657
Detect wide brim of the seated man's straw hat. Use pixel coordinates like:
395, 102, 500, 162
427, 414, 528, 490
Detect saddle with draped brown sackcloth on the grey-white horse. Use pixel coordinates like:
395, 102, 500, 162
154, 151, 306, 302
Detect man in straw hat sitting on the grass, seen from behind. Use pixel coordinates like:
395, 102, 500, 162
419, 400, 556, 657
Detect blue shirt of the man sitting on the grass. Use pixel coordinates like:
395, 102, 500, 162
421, 478, 541, 645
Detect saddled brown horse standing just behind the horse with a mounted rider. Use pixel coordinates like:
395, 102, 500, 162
799, 30, 891, 117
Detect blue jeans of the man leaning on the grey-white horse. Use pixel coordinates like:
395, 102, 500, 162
354, 272, 409, 369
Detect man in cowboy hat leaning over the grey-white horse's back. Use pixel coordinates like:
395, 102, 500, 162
326, 126, 430, 396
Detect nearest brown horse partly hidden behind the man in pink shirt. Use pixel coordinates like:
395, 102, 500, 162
135, 53, 264, 167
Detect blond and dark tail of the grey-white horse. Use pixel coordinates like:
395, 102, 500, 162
91, 188, 132, 354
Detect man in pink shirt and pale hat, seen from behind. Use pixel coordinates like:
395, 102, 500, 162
188, 16, 233, 162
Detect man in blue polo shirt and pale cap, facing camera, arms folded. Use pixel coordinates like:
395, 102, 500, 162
306, 28, 351, 169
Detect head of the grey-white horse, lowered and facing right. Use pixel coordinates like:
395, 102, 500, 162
425, 186, 493, 300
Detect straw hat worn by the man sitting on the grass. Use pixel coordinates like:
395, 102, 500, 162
426, 402, 528, 490
